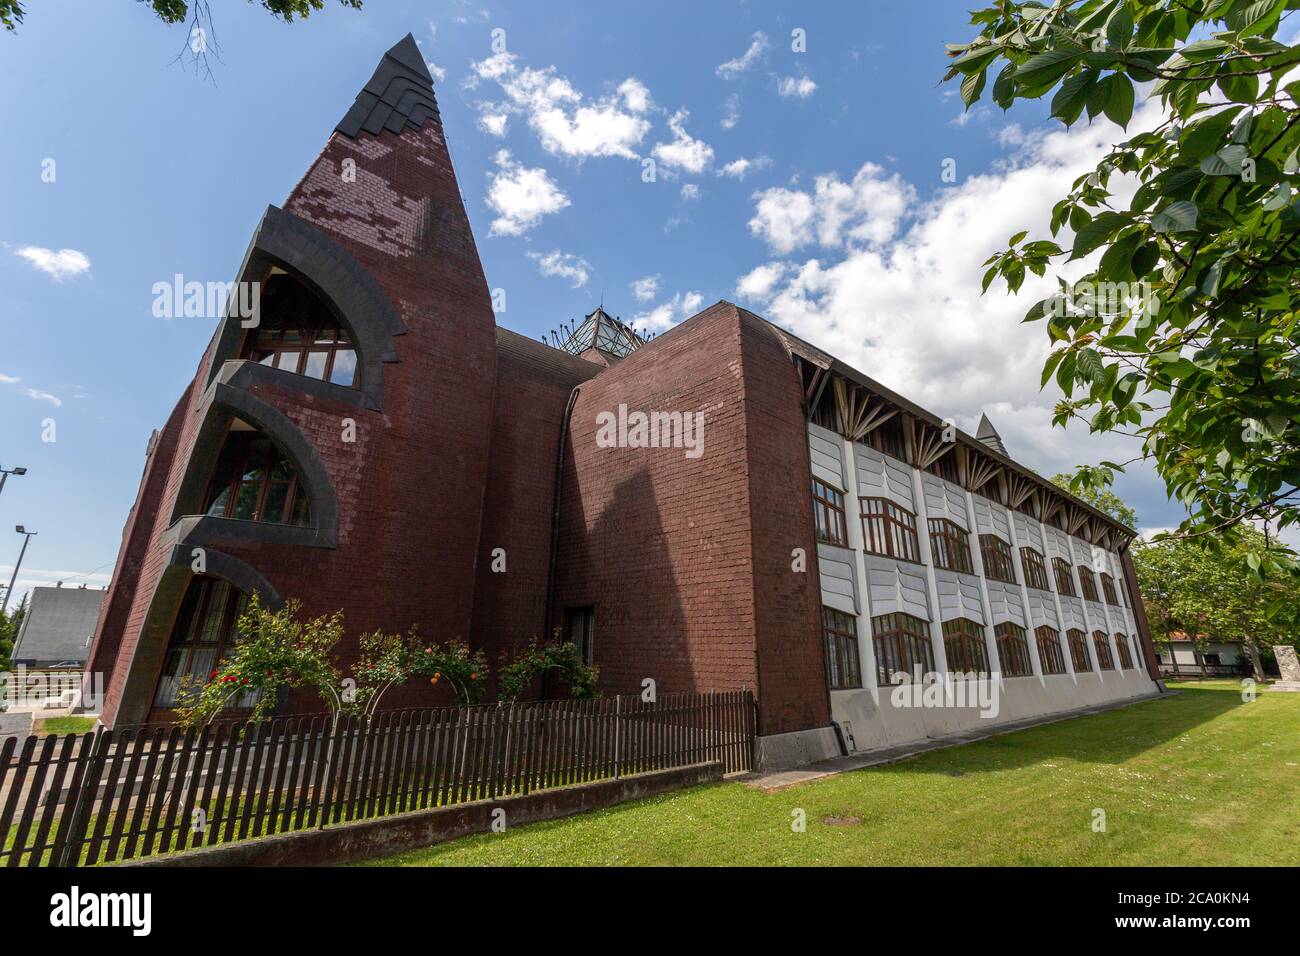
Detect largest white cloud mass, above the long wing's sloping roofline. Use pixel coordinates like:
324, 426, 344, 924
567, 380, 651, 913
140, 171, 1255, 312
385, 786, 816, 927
737, 98, 1157, 481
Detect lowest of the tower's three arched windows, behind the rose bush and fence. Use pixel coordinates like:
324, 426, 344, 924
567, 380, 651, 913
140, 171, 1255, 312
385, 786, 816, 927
153, 576, 257, 709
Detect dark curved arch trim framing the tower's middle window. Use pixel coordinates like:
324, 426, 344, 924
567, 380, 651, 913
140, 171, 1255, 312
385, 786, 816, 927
168, 377, 338, 548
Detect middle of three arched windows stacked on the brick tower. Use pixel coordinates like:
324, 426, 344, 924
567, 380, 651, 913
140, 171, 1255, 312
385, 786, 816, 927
203, 419, 311, 525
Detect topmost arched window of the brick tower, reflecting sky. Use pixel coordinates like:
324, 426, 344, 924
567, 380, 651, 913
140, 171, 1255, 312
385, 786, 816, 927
239, 272, 360, 386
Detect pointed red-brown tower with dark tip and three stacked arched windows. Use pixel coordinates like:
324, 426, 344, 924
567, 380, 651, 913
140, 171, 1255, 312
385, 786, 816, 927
88, 34, 495, 726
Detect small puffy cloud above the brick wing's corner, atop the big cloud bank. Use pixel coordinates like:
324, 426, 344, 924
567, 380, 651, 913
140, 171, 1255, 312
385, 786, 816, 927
749, 163, 917, 255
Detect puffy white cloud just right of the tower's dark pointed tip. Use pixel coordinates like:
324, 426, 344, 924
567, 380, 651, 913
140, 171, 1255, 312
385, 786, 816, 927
467, 53, 654, 161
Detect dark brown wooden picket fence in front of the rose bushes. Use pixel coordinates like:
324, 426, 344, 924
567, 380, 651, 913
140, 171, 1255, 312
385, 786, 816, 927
0, 691, 755, 866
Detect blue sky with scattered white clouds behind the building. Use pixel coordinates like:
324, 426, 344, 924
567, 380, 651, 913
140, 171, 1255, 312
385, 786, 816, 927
0, 0, 1178, 592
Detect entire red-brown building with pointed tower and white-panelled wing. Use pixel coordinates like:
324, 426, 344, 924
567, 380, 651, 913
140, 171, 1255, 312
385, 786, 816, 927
87, 36, 1158, 765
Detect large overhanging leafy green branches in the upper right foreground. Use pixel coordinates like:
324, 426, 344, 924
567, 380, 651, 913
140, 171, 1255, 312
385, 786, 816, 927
945, 0, 1300, 572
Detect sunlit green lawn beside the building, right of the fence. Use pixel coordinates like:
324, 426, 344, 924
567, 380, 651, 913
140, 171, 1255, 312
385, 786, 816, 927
353, 680, 1300, 866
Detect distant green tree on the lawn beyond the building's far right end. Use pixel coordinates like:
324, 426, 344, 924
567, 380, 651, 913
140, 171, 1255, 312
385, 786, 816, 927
1132, 525, 1300, 680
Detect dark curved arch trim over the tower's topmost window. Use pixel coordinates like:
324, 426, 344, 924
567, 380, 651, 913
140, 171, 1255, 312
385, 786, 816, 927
207, 206, 406, 411
